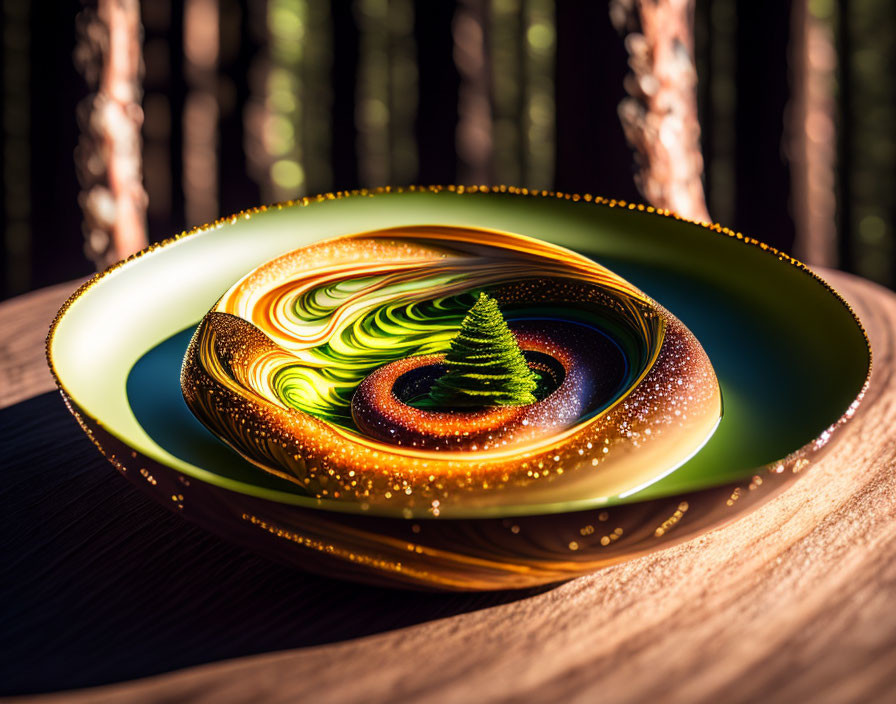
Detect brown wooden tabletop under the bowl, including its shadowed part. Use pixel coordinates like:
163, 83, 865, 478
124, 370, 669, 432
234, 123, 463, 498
0, 272, 896, 704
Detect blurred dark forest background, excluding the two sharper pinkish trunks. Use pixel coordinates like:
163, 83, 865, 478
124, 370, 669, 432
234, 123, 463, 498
0, 0, 896, 298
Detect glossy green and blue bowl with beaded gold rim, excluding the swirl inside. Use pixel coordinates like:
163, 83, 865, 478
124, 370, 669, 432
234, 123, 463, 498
47, 187, 871, 589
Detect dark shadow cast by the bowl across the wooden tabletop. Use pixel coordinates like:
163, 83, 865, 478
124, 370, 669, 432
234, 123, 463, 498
0, 392, 544, 695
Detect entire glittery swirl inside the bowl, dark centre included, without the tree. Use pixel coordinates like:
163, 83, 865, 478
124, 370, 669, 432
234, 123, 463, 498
181, 225, 722, 517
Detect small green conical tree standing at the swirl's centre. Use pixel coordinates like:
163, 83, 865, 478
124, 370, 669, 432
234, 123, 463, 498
429, 293, 537, 408
